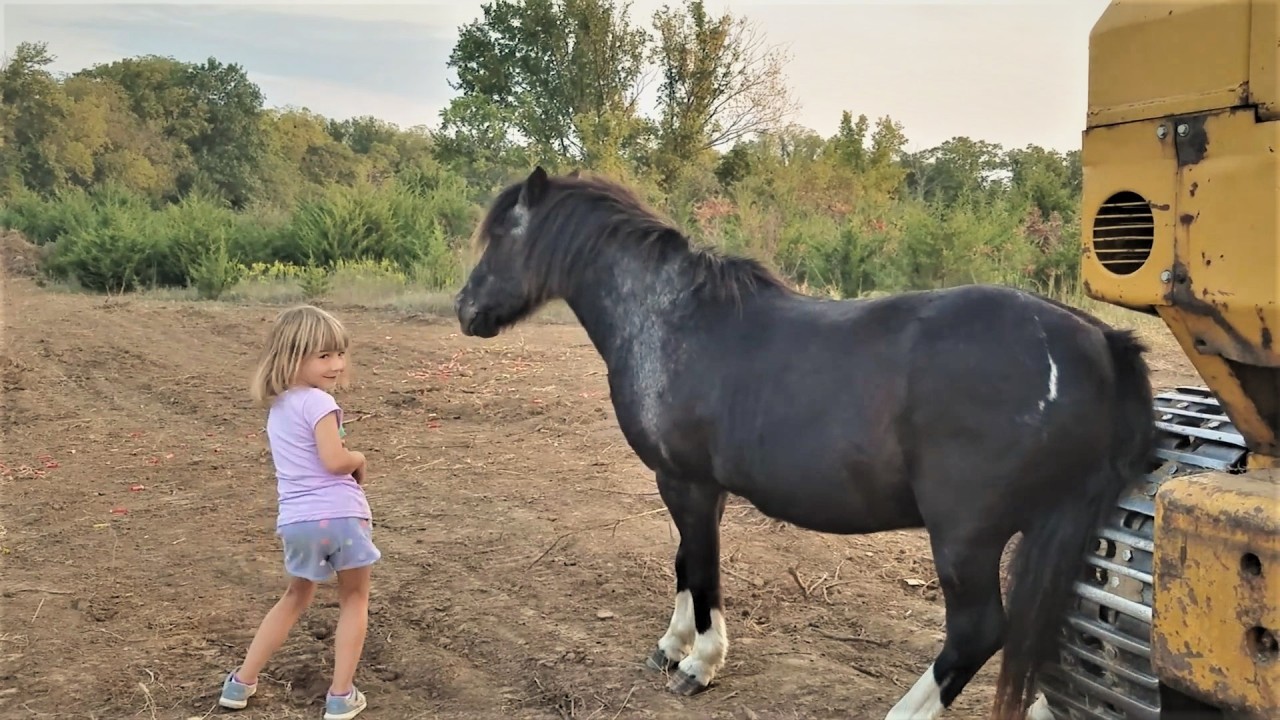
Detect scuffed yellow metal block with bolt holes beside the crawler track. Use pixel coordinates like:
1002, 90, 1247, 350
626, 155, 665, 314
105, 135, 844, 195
1151, 469, 1280, 717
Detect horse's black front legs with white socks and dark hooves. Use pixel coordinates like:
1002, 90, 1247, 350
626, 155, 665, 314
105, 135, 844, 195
649, 473, 728, 696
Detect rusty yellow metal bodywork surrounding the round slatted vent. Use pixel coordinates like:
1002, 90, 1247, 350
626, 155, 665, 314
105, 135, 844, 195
1080, 102, 1280, 456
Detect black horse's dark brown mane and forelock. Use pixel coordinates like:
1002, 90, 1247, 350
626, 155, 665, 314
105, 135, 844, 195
475, 170, 791, 301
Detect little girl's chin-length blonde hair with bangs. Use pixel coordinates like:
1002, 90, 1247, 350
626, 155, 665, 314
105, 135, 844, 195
250, 305, 351, 405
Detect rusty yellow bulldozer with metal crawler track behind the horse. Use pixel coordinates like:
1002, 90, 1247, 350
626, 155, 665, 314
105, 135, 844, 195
1039, 0, 1280, 720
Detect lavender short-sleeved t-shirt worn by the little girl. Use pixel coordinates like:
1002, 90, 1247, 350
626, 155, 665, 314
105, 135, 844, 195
266, 387, 372, 528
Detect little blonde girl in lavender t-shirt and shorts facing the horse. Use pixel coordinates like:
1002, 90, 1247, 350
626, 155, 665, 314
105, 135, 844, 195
218, 305, 381, 720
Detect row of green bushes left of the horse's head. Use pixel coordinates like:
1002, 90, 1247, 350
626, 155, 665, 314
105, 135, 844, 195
0, 176, 475, 299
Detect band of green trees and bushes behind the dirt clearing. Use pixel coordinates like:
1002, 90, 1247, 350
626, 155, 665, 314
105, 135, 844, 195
0, 0, 1082, 297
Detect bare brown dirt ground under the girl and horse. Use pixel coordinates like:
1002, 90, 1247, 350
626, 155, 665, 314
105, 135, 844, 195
0, 254, 1196, 720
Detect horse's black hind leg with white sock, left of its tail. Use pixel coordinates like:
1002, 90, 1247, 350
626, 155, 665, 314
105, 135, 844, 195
886, 530, 1007, 720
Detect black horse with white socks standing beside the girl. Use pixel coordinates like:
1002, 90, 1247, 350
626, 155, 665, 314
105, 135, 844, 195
454, 168, 1155, 720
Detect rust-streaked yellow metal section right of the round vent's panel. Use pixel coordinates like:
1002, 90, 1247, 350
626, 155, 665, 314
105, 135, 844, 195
1158, 110, 1280, 456
